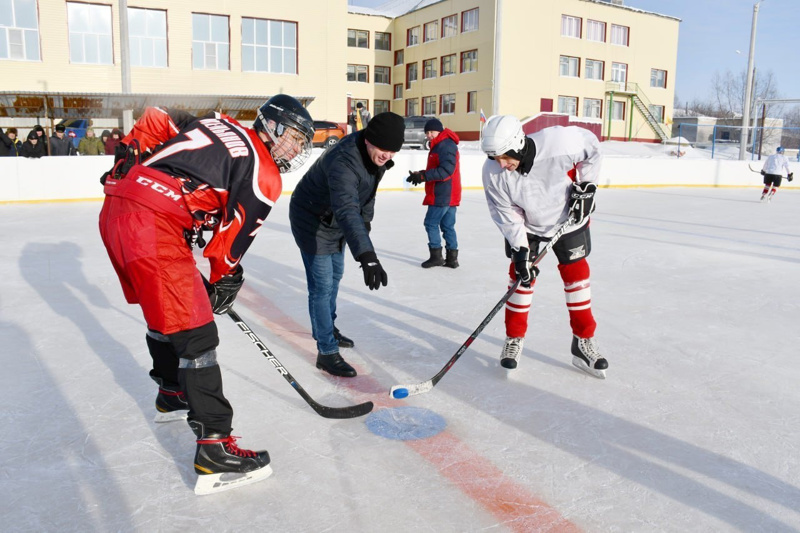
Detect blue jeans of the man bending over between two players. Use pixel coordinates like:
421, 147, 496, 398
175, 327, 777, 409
300, 250, 344, 355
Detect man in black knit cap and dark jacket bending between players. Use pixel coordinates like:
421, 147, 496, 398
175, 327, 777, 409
289, 112, 405, 377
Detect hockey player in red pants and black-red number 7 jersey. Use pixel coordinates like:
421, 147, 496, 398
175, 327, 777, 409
100, 94, 314, 494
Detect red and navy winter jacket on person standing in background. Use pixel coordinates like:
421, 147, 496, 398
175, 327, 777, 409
422, 128, 461, 207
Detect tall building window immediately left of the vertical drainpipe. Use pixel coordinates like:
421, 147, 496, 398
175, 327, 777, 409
67, 2, 114, 65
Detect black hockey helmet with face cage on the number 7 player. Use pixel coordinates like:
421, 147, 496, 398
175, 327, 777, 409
253, 94, 314, 173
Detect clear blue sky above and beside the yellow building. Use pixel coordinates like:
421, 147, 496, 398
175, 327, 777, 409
350, 0, 800, 103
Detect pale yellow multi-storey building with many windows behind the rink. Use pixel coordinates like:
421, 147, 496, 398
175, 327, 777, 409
0, 0, 679, 141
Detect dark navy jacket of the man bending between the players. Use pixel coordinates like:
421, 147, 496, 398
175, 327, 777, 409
289, 132, 394, 259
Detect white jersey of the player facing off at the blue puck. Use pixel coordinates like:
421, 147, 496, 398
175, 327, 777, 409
483, 126, 602, 249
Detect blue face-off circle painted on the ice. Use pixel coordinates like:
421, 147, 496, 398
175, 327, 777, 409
366, 406, 447, 440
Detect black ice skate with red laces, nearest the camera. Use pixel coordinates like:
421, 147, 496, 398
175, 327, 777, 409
189, 420, 272, 495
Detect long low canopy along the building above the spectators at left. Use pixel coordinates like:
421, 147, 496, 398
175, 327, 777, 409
0, 91, 314, 120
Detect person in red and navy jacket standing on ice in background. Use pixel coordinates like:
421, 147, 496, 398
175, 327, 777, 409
406, 118, 461, 268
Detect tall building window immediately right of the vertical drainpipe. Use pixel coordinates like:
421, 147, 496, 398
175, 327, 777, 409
128, 7, 167, 68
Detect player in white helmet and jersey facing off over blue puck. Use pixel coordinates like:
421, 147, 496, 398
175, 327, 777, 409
481, 115, 608, 378
